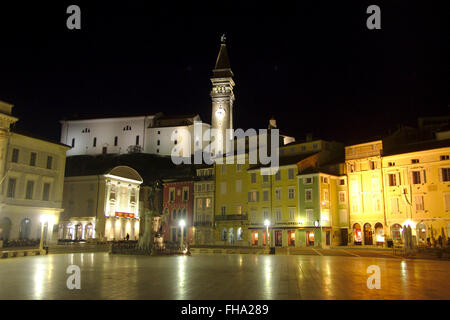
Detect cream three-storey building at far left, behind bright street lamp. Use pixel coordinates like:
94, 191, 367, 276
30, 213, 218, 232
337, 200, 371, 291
0, 101, 70, 247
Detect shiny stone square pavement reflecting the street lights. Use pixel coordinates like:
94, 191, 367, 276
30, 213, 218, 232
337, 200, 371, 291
0, 253, 450, 300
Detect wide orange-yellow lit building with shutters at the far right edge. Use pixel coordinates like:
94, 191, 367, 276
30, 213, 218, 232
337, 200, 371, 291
383, 140, 450, 245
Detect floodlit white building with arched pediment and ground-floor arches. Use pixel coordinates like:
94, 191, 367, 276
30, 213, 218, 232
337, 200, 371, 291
58, 166, 143, 241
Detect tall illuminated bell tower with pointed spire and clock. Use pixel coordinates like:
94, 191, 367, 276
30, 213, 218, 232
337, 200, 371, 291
211, 35, 234, 155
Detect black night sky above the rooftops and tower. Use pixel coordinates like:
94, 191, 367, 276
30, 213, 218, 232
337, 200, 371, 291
0, 0, 450, 143
